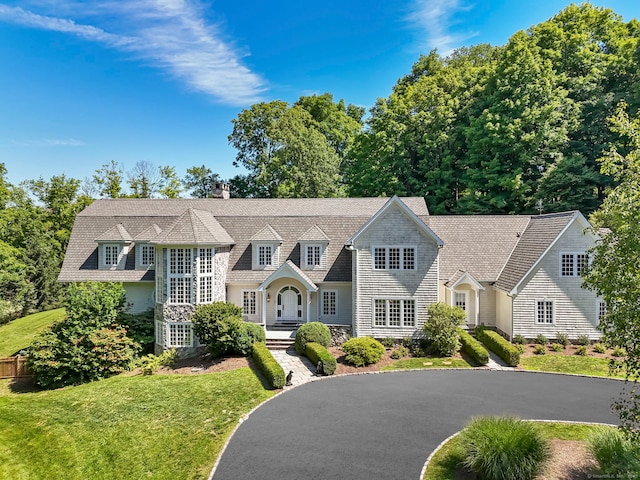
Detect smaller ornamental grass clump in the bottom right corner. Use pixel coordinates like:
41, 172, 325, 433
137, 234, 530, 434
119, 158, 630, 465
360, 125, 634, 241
587, 427, 640, 478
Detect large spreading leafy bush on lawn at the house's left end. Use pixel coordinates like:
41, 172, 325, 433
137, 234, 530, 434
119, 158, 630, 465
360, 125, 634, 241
27, 282, 139, 388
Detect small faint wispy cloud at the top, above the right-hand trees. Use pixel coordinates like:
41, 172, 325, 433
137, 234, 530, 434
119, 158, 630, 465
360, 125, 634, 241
408, 0, 477, 55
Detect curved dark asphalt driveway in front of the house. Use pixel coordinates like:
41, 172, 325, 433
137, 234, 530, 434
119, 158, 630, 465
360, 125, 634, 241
213, 370, 623, 480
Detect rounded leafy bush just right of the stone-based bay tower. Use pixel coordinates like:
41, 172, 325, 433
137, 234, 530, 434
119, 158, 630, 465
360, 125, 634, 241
191, 302, 242, 357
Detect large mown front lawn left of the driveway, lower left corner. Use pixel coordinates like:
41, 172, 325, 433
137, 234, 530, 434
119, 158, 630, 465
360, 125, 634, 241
0, 368, 273, 480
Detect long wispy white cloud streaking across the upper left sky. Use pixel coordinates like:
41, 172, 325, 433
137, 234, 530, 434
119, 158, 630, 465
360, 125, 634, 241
0, 0, 264, 105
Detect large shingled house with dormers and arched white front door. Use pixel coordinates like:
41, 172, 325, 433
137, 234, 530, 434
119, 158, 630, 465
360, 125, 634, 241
59, 189, 604, 354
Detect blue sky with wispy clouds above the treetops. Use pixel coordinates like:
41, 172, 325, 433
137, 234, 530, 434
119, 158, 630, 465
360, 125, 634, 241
0, 0, 640, 190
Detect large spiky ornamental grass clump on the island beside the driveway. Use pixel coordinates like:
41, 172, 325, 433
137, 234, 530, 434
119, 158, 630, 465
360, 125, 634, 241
461, 417, 551, 480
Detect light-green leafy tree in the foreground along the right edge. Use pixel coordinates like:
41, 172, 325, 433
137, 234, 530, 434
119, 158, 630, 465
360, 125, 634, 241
583, 103, 640, 442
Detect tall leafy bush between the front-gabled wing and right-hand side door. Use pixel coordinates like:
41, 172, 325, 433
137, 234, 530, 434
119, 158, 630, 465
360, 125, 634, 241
423, 302, 466, 357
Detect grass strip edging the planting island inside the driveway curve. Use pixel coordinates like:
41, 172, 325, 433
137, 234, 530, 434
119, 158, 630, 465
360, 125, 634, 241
423, 422, 606, 480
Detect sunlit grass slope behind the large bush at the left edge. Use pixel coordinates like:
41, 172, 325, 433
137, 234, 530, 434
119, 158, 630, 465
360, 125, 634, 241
0, 308, 65, 357
